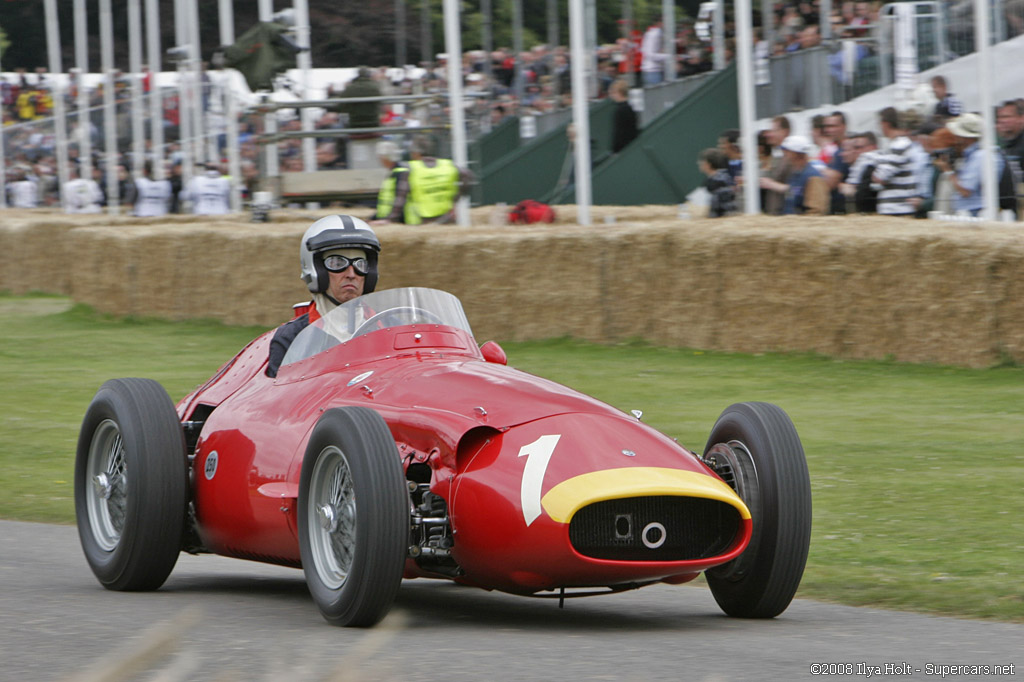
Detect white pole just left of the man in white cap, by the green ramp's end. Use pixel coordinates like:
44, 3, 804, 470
735, 0, 761, 215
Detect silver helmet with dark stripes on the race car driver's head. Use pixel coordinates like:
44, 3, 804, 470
299, 215, 381, 294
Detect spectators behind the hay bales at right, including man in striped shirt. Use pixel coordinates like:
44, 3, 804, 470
698, 76, 1024, 219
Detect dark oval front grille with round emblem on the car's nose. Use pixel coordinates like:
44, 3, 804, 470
569, 496, 740, 561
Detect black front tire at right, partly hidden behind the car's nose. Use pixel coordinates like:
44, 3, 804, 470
705, 402, 811, 619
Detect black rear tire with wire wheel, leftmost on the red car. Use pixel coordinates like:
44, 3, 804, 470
75, 379, 188, 591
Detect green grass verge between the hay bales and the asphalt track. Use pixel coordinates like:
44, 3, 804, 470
0, 296, 1024, 622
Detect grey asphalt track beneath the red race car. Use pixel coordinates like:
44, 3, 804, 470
0, 521, 1024, 682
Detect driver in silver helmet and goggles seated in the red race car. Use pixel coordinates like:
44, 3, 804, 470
266, 215, 381, 377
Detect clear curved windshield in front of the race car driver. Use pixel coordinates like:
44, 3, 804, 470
282, 287, 473, 366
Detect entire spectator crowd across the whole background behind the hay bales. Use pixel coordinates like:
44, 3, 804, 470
0, 0, 1024, 216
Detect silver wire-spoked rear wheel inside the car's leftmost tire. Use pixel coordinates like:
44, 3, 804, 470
86, 419, 128, 552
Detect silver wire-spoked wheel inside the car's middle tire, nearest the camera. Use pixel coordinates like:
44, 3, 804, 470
306, 445, 356, 590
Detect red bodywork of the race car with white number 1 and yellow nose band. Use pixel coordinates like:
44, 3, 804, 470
178, 305, 751, 593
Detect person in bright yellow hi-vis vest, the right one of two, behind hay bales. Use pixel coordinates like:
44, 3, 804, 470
389, 138, 470, 225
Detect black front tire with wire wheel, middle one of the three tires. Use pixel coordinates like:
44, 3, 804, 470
299, 407, 410, 628
